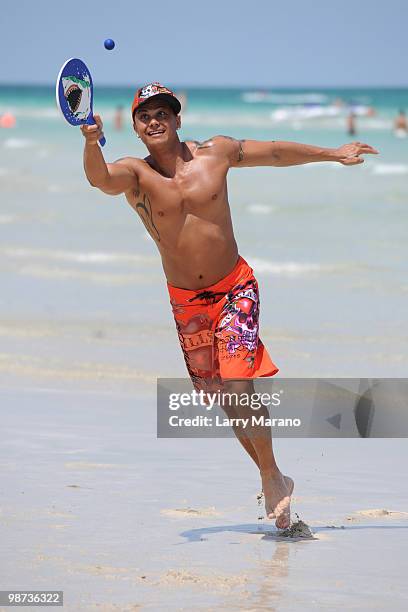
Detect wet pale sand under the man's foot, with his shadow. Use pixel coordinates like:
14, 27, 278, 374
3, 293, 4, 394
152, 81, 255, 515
0, 381, 408, 611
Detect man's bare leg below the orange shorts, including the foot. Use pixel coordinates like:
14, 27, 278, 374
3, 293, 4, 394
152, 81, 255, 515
222, 379, 293, 529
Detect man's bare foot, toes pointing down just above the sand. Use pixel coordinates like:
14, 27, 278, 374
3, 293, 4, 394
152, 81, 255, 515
261, 472, 294, 529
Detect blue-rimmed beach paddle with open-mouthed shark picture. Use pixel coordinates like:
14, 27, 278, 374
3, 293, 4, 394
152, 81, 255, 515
55, 57, 106, 147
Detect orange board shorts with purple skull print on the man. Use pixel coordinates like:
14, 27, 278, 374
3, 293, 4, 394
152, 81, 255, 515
167, 257, 279, 391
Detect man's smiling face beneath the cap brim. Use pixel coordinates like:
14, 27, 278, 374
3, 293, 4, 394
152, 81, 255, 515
133, 100, 180, 146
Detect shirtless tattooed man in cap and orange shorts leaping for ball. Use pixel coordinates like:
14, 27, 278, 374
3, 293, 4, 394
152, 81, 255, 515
81, 83, 377, 529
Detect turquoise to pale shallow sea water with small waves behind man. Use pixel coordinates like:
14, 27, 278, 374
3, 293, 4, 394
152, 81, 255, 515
0, 86, 408, 377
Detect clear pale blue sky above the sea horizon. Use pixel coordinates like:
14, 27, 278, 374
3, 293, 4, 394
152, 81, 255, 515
0, 0, 408, 87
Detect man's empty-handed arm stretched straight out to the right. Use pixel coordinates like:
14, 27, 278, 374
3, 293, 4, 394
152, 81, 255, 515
230, 139, 378, 168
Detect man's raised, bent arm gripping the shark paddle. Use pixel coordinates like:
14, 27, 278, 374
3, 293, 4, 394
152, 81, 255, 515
81, 115, 138, 195
